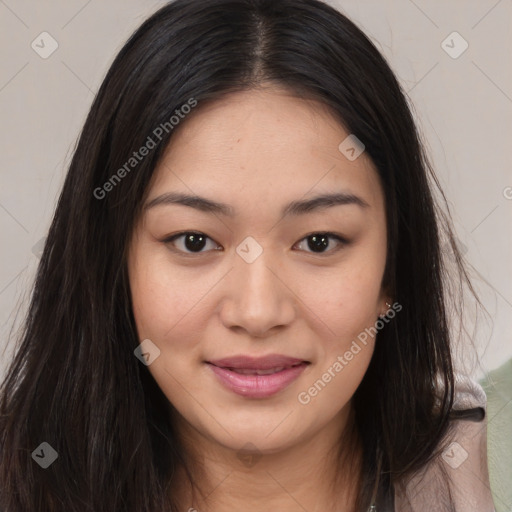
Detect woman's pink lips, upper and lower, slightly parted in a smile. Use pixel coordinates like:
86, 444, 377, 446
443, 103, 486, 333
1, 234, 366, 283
207, 354, 309, 398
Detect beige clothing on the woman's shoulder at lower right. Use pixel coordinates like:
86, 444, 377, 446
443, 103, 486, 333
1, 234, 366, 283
395, 375, 495, 512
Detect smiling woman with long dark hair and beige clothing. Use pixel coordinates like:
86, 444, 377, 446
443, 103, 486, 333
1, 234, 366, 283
0, 0, 493, 512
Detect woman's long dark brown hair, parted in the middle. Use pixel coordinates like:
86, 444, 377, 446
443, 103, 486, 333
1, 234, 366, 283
0, 0, 488, 512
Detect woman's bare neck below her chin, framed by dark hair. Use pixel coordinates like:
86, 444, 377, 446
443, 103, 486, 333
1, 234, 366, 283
172, 403, 362, 512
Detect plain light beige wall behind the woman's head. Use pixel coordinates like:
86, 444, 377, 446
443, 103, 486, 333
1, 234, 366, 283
0, 0, 512, 378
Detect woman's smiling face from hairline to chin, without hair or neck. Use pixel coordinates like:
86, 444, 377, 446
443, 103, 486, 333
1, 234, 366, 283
128, 88, 389, 453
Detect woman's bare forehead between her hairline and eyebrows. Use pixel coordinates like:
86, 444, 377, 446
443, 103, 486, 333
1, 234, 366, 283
144, 87, 383, 218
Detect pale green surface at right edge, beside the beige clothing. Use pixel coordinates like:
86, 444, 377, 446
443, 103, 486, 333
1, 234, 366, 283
480, 359, 512, 512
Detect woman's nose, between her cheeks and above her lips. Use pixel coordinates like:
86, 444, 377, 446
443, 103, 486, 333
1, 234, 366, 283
220, 250, 298, 338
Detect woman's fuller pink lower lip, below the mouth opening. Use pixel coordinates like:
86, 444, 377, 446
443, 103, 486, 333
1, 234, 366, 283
208, 363, 307, 398
